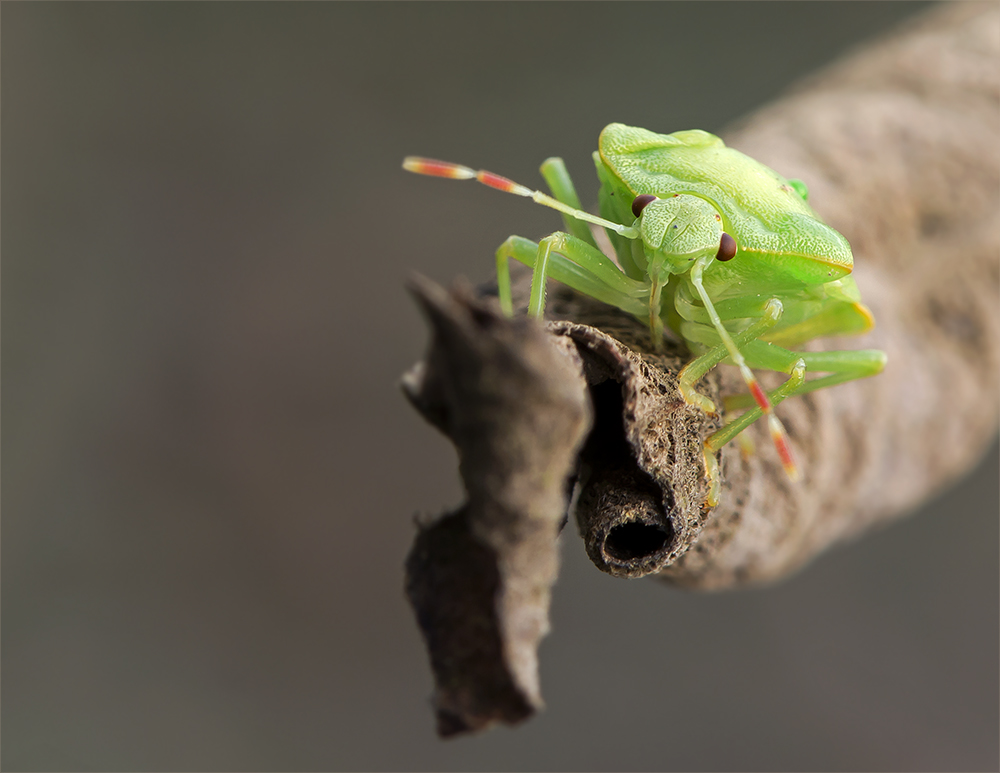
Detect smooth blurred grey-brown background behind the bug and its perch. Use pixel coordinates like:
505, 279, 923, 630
2, 3, 1000, 770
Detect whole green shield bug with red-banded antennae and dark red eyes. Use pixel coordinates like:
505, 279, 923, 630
403, 123, 885, 505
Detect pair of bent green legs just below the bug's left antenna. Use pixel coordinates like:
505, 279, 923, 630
497, 232, 649, 317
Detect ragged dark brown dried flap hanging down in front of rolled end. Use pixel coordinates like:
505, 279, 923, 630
403, 280, 590, 736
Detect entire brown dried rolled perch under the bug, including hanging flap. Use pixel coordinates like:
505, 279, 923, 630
406, 3, 1000, 732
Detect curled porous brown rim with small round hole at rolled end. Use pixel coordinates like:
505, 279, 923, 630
549, 312, 718, 577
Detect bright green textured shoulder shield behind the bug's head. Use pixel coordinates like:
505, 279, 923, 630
598, 123, 854, 286
